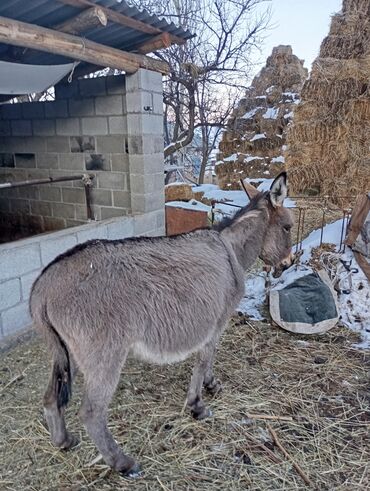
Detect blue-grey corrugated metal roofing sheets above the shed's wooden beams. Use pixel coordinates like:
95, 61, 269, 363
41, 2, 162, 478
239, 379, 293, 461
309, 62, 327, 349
0, 0, 192, 66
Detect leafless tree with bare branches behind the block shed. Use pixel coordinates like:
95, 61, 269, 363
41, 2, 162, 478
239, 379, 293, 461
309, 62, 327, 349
131, 0, 270, 182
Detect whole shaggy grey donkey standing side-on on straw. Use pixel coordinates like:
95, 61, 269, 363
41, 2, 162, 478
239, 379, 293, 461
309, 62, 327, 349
30, 173, 292, 475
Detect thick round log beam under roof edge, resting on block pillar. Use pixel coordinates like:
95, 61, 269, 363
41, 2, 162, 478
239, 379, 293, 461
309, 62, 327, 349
0, 17, 168, 73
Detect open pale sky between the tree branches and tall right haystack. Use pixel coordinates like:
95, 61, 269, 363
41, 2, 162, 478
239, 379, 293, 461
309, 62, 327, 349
255, 0, 342, 73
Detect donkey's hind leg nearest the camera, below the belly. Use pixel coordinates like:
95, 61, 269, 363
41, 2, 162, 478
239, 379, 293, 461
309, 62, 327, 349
80, 352, 140, 477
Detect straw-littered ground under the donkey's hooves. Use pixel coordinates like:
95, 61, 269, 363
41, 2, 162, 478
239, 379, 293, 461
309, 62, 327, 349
0, 317, 370, 491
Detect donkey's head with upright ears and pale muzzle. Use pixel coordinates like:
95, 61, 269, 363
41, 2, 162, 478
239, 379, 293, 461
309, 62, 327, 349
242, 172, 293, 267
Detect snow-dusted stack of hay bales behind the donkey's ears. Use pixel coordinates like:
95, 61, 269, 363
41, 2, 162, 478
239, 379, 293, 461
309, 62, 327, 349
215, 46, 307, 189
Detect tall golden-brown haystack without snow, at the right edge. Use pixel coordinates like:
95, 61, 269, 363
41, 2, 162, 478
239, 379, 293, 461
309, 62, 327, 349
286, 0, 370, 206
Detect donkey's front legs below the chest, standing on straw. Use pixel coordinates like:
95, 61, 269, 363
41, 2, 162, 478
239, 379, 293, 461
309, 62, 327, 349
187, 340, 221, 419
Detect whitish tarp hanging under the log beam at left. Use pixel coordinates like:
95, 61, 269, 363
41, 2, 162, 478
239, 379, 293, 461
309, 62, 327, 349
0, 61, 74, 95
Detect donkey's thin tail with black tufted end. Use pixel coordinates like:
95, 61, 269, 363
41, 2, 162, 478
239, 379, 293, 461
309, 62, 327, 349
30, 297, 72, 409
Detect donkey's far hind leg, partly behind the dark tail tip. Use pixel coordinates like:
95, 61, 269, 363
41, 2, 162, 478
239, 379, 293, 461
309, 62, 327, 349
44, 361, 79, 450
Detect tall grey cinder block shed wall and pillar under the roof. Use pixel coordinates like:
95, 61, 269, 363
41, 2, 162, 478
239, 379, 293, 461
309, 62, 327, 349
0, 70, 164, 242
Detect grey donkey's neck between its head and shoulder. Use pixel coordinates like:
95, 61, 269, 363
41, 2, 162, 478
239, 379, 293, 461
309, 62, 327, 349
220, 208, 269, 271
